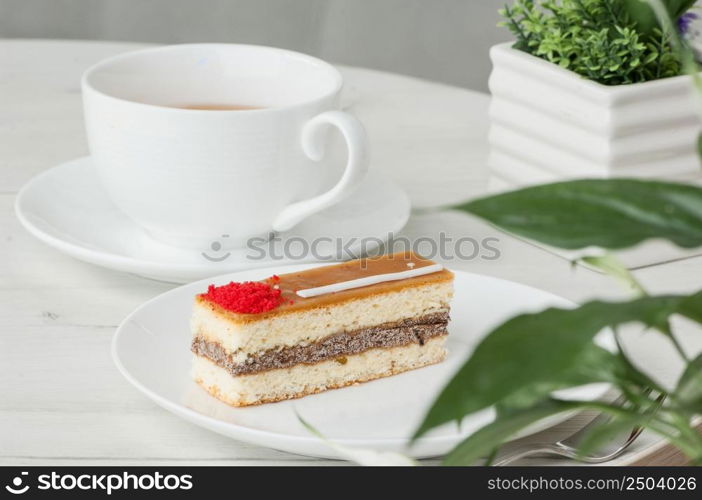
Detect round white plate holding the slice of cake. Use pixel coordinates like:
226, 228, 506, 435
112, 266, 607, 458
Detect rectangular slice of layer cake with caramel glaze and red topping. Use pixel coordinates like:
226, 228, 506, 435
191, 253, 453, 406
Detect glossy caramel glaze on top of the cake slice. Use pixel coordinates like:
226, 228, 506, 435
195, 252, 453, 323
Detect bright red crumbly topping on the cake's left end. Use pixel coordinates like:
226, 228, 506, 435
203, 281, 283, 314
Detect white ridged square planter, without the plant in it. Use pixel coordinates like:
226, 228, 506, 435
489, 43, 702, 185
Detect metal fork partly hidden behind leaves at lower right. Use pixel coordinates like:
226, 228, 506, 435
492, 394, 665, 466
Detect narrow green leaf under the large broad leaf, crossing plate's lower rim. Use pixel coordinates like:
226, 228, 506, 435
443, 400, 575, 465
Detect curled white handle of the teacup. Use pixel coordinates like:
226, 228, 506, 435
273, 111, 368, 231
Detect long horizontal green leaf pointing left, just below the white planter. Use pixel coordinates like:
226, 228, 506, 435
455, 179, 702, 249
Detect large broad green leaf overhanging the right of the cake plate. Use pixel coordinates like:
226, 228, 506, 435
414, 296, 685, 439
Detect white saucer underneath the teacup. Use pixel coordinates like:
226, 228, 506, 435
15, 157, 410, 283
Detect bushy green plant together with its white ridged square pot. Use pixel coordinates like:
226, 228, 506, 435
489, 0, 700, 185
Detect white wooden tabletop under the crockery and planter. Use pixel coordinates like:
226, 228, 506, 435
0, 40, 702, 465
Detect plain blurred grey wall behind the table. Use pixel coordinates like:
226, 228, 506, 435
0, 0, 510, 90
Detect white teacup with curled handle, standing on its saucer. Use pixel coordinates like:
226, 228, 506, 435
82, 44, 368, 249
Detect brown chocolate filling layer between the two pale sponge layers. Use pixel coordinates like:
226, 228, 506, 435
191, 312, 449, 376
